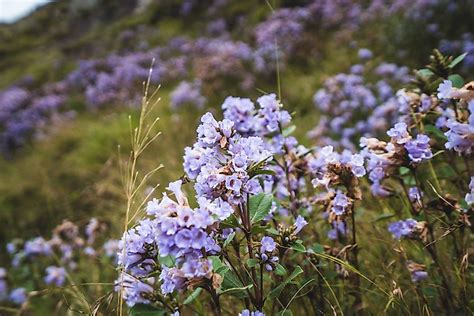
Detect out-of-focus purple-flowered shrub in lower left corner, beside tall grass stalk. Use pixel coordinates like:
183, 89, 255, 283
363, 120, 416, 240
0, 218, 119, 309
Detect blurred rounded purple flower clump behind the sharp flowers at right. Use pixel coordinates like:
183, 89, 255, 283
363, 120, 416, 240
308, 56, 410, 150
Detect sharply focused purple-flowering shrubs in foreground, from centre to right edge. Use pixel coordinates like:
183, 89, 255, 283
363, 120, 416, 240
110, 51, 474, 315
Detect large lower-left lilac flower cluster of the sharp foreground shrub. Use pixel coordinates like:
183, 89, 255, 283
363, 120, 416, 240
117, 180, 229, 306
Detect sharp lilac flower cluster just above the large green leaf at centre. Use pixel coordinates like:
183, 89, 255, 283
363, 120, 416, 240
184, 113, 272, 205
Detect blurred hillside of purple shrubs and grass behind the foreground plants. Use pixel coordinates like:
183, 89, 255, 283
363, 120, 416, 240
0, 0, 474, 312
